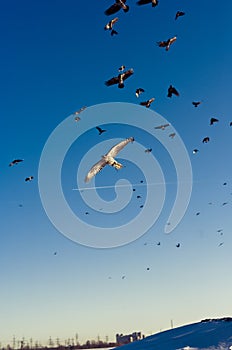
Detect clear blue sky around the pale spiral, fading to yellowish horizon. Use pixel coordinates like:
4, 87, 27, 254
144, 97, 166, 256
0, 0, 232, 344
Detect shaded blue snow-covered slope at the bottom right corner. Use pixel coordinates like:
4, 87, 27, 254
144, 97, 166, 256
115, 318, 232, 350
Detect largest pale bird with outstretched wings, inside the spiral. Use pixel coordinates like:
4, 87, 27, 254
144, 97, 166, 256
85, 137, 134, 182
